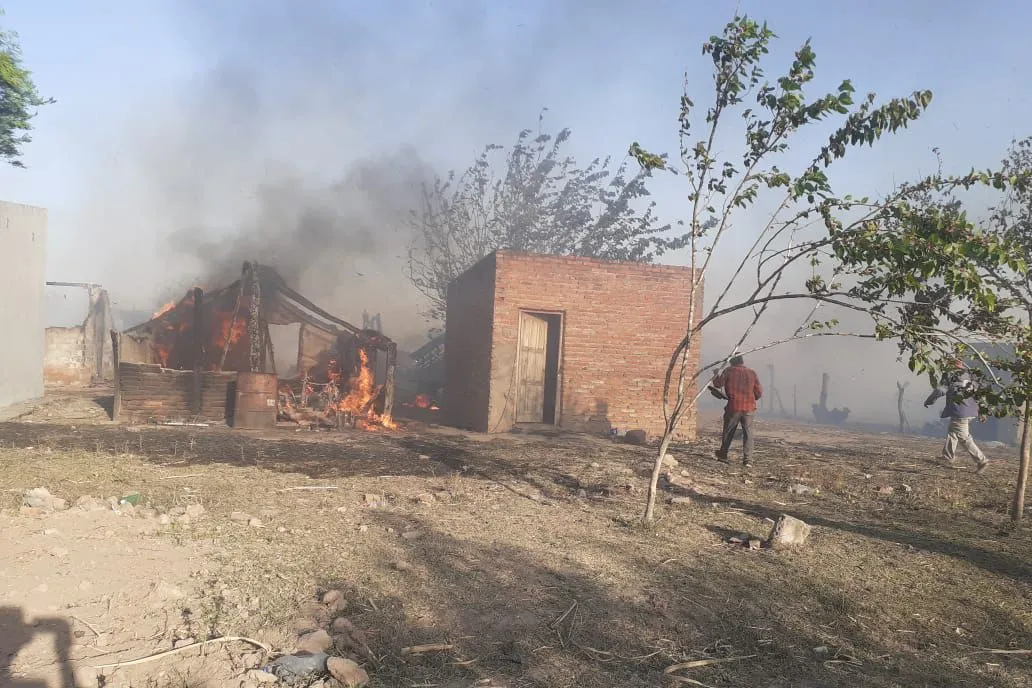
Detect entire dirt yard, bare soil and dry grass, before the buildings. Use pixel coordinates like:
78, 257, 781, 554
0, 393, 1032, 688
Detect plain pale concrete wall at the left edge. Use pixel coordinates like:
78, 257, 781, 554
0, 201, 46, 406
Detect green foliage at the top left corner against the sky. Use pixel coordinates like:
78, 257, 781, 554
0, 10, 54, 167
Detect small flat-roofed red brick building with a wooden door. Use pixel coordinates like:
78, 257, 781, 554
444, 251, 702, 437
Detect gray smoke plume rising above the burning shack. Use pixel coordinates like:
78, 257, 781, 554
85, 2, 478, 347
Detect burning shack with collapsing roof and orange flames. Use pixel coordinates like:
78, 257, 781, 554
111, 263, 397, 427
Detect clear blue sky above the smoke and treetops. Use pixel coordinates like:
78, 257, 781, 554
0, 0, 1032, 290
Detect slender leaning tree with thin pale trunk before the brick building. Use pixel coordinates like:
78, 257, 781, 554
631, 17, 1020, 521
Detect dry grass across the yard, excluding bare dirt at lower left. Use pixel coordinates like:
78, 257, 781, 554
0, 408, 1032, 687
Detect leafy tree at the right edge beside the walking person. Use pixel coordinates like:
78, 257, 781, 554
891, 144, 1032, 521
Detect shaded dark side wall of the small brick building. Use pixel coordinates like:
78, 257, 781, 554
443, 254, 494, 432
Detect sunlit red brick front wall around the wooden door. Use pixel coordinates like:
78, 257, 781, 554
487, 252, 702, 437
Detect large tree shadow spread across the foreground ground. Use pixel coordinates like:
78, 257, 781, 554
318, 513, 1032, 688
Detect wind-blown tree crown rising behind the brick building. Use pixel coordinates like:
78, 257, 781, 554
408, 113, 676, 323
